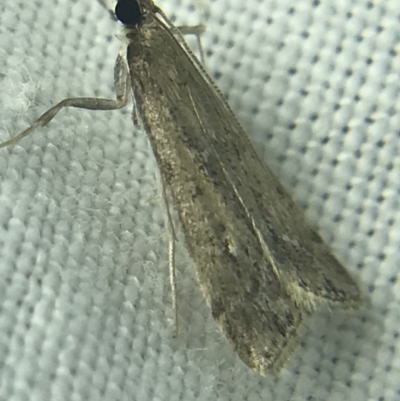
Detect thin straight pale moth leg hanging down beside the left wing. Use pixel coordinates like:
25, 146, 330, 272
161, 175, 179, 338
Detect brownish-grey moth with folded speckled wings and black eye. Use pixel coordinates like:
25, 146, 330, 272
0, 0, 361, 375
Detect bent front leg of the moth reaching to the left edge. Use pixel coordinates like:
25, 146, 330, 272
0, 55, 130, 148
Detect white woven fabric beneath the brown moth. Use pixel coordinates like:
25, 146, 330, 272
0, 0, 400, 401
